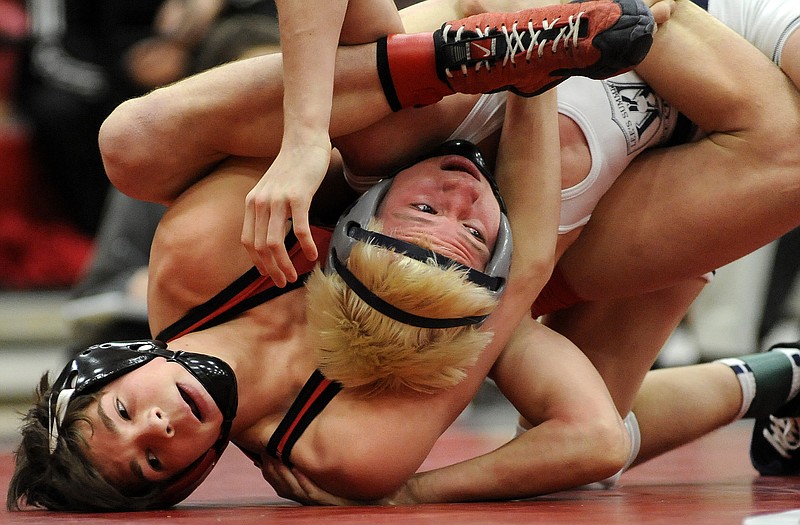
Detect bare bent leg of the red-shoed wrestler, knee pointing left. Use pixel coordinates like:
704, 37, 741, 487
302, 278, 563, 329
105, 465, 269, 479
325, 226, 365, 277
100, 44, 390, 203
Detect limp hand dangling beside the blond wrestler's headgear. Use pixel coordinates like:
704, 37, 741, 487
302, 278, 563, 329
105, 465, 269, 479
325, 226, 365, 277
242, 141, 331, 287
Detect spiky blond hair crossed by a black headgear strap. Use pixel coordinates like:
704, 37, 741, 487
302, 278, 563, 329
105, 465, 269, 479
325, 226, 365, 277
306, 229, 497, 393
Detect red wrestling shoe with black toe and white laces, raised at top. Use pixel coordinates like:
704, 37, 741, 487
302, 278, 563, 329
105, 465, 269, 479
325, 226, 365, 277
434, 0, 655, 96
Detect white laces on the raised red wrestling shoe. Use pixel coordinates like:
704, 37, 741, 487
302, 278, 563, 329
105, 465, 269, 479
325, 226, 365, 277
442, 11, 584, 77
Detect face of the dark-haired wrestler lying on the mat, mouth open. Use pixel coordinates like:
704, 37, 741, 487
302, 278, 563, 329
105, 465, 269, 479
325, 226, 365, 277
84, 357, 223, 488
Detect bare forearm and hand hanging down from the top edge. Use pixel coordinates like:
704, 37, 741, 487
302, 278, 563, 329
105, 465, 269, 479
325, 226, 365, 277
242, 0, 347, 286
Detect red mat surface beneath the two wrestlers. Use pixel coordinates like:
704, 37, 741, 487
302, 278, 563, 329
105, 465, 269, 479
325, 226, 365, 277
0, 423, 800, 525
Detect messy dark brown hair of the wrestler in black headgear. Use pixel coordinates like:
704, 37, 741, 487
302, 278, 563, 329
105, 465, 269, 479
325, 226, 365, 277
6, 374, 170, 512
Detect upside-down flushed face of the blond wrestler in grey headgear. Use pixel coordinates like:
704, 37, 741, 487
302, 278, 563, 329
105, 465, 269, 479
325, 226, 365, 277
378, 155, 500, 270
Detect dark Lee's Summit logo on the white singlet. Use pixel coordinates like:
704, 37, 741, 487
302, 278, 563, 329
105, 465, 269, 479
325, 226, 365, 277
602, 80, 674, 155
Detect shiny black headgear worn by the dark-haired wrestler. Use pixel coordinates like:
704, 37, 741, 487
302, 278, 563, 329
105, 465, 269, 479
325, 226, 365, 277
48, 340, 238, 507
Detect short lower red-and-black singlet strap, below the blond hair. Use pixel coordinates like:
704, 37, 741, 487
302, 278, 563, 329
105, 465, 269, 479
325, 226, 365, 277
267, 370, 342, 466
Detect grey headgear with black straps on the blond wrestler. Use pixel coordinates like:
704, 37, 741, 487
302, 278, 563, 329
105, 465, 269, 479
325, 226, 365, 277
325, 140, 512, 328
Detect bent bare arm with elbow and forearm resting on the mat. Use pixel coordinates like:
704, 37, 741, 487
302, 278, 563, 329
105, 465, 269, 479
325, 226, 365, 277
393, 319, 628, 504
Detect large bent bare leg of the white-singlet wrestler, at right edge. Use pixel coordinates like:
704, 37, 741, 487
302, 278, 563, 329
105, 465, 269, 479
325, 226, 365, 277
560, 0, 800, 299
